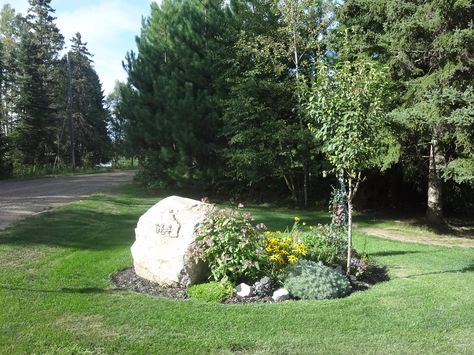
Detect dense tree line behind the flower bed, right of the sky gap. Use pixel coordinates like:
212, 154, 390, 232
114, 0, 474, 220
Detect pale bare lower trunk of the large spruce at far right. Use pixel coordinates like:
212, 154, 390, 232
426, 139, 444, 224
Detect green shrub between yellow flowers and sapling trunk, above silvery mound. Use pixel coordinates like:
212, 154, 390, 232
301, 224, 347, 267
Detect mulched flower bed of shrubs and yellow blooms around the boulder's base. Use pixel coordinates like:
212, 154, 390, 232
114, 204, 387, 303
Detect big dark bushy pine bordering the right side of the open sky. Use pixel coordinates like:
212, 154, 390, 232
120, 0, 231, 185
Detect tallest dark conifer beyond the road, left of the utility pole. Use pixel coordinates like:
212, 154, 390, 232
16, 0, 63, 167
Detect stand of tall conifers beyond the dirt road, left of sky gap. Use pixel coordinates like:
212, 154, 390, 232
0, 0, 111, 177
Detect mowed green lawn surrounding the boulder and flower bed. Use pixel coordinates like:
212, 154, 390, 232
0, 187, 474, 354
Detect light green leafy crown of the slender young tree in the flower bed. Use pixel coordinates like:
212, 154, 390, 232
307, 59, 392, 177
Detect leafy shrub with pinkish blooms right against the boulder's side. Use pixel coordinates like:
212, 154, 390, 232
194, 209, 265, 283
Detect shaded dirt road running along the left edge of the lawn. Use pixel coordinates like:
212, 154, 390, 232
0, 171, 135, 229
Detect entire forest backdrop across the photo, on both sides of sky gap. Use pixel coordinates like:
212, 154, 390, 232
0, 0, 474, 221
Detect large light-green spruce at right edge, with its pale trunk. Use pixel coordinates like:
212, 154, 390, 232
338, 0, 474, 223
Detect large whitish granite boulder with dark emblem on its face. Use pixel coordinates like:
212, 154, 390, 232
131, 196, 214, 286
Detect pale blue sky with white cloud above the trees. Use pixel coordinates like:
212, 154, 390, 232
4, 0, 157, 95
